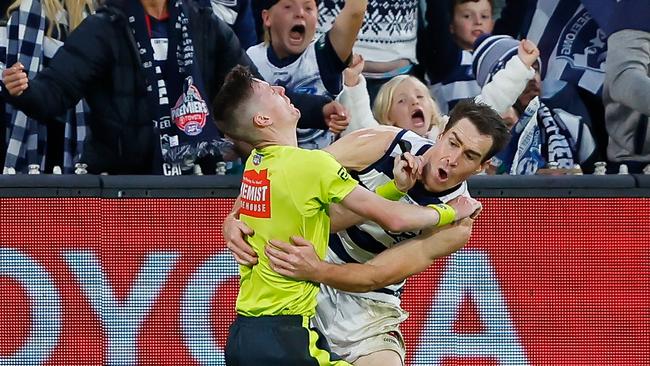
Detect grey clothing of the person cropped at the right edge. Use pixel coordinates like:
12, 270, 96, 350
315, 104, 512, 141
603, 27, 650, 173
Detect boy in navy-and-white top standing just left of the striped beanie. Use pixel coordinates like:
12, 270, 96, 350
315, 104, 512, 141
418, 0, 494, 113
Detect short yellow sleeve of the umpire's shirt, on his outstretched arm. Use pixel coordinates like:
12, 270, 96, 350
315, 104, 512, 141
292, 150, 358, 205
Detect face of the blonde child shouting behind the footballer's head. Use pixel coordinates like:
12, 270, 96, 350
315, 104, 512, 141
388, 78, 434, 136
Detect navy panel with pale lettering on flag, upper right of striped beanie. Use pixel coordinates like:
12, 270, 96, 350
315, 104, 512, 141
557, 9, 607, 72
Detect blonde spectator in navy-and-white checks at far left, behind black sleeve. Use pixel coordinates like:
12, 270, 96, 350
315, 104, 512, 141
1, 0, 95, 173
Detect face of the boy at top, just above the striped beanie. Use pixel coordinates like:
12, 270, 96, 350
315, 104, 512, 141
449, 0, 494, 50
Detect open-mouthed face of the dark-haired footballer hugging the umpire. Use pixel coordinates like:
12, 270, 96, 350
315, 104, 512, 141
422, 118, 492, 192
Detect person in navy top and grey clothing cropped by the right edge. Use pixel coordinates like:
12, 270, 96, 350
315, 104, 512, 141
583, 0, 650, 173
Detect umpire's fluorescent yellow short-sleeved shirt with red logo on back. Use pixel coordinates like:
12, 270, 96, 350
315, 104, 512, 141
236, 146, 358, 317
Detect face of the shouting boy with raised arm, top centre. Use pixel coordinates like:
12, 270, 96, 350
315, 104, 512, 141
262, 0, 318, 58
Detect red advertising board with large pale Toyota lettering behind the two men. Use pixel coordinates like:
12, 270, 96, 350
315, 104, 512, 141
0, 198, 650, 365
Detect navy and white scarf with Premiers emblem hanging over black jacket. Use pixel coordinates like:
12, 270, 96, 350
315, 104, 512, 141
127, 0, 228, 175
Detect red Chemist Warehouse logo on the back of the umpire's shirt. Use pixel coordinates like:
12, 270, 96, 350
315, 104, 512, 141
239, 169, 271, 219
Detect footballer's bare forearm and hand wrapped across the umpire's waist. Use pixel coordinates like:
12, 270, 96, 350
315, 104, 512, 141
265, 218, 474, 292
